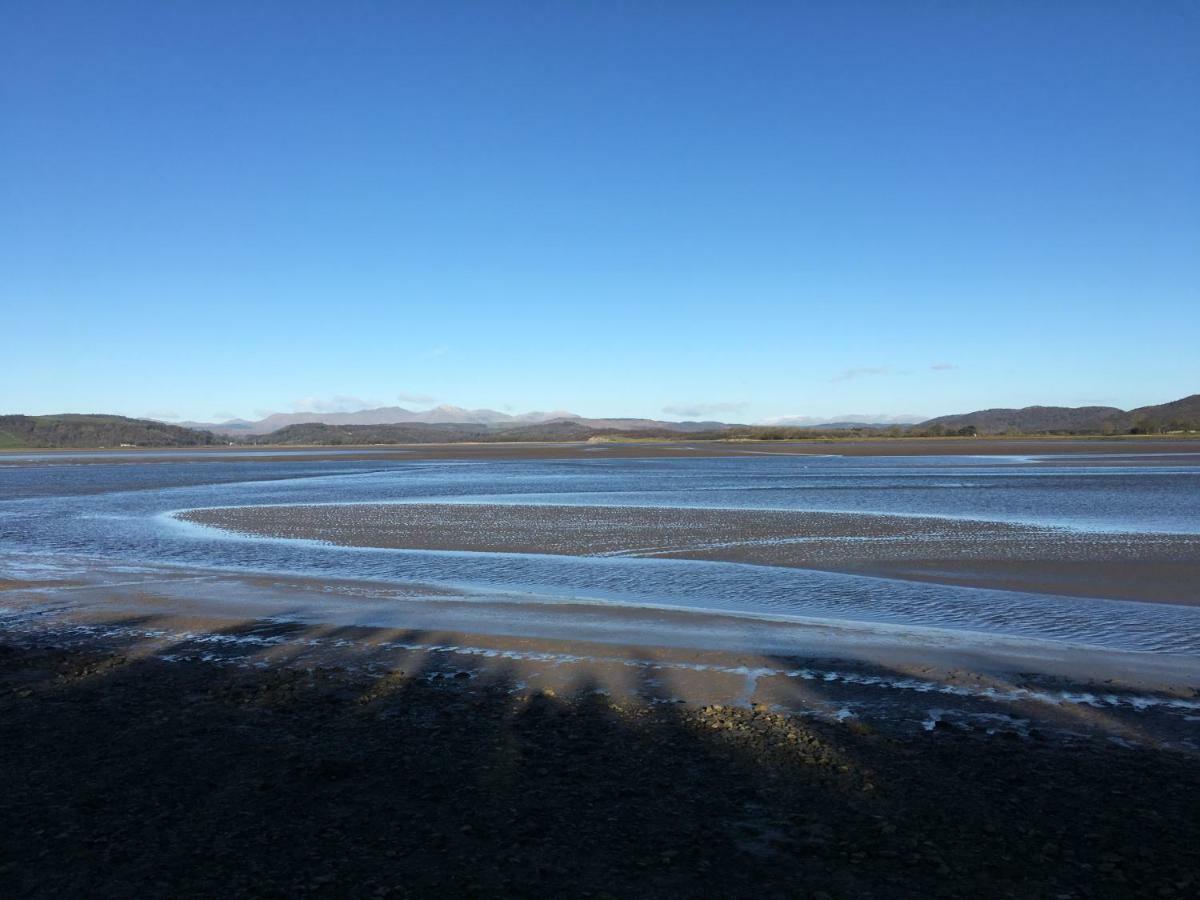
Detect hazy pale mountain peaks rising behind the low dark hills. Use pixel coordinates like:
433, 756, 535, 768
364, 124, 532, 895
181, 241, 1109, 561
179, 406, 724, 436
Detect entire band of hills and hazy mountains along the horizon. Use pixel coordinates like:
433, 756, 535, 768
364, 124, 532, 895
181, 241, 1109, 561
0, 394, 1200, 449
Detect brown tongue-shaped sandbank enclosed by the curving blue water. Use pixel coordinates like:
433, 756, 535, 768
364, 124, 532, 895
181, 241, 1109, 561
179, 504, 1200, 605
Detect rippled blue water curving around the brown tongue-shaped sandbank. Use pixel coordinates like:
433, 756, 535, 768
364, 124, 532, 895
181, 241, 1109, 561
0, 454, 1200, 653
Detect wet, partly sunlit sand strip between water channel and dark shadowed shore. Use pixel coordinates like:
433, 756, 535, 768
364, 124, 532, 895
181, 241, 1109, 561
0, 566, 1200, 724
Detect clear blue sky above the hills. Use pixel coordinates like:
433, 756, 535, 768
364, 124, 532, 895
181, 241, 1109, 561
0, 0, 1200, 421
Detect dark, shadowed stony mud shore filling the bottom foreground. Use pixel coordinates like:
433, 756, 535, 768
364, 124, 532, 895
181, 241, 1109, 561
0, 647, 1200, 898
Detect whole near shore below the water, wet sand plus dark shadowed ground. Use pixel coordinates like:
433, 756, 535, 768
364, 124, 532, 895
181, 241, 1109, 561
0, 560, 1200, 899
